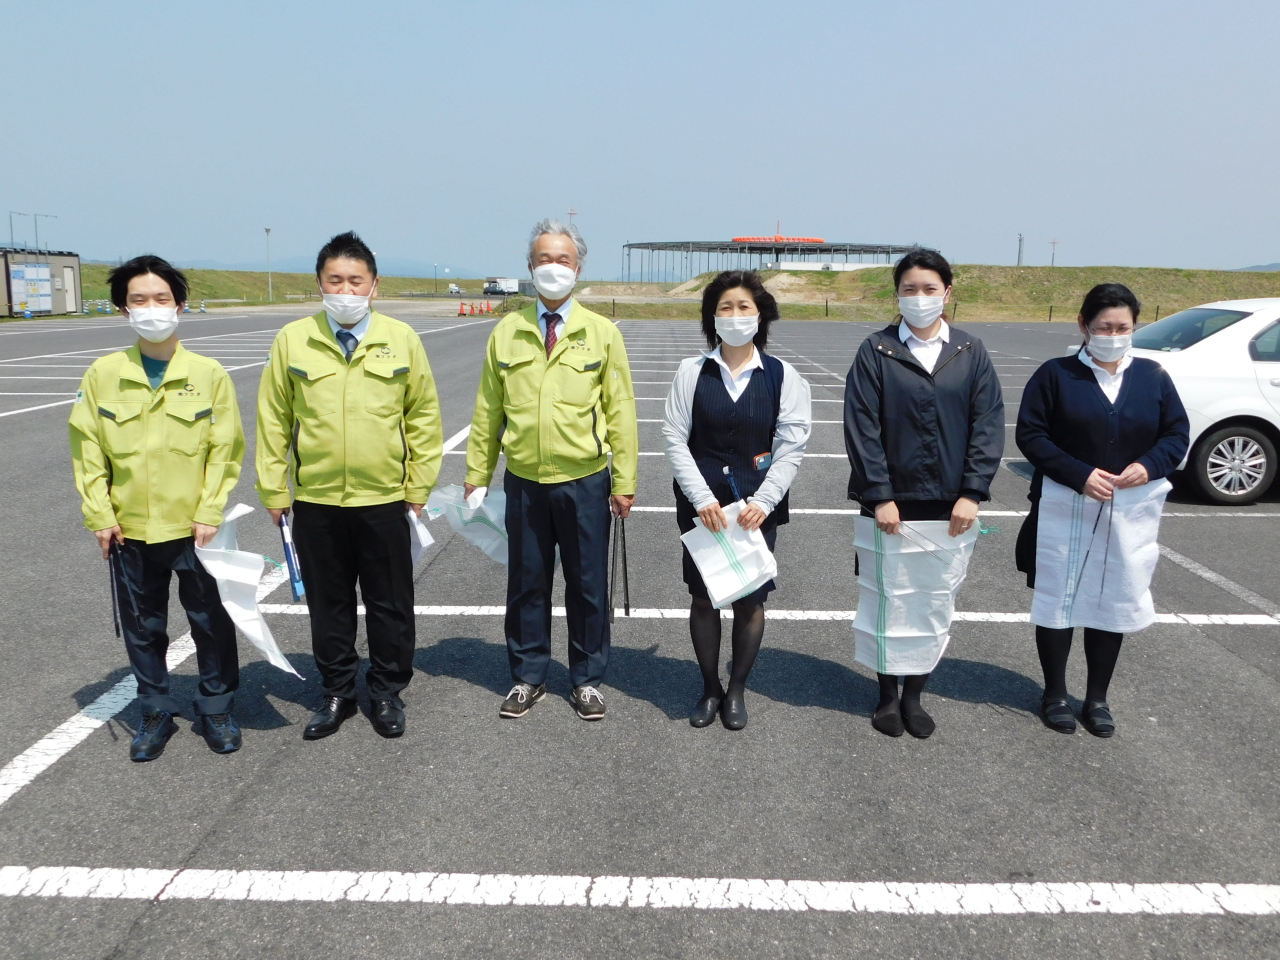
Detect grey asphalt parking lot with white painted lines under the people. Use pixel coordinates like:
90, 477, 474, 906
0, 303, 1280, 957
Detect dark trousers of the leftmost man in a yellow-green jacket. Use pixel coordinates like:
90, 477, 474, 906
116, 536, 239, 716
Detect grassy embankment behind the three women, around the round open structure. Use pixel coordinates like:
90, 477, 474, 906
586, 264, 1280, 323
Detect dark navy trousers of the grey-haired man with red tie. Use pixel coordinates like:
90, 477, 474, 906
502, 468, 612, 686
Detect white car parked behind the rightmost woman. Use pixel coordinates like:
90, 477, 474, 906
1133, 298, 1280, 512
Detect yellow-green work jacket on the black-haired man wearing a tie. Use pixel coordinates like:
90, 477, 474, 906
256, 311, 444, 509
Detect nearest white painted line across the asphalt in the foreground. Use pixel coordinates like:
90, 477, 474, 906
0, 867, 1280, 916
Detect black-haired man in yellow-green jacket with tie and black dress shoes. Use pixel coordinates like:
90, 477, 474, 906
257, 233, 444, 740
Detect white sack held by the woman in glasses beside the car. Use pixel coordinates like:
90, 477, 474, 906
1032, 477, 1174, 634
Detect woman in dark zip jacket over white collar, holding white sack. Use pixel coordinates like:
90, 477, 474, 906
845, 250, 1005, 739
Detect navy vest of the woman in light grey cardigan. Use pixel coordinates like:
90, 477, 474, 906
676, 353, 790, 526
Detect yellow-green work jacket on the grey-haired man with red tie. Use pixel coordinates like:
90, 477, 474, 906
467, 302, 639, 495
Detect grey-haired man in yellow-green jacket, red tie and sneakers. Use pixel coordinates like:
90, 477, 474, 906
465, 220, 639, 721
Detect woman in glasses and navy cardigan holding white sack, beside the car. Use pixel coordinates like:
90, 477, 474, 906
1015, 283, 1189, 737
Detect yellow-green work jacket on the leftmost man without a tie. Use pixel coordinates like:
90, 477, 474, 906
69, 343, 244, 543
